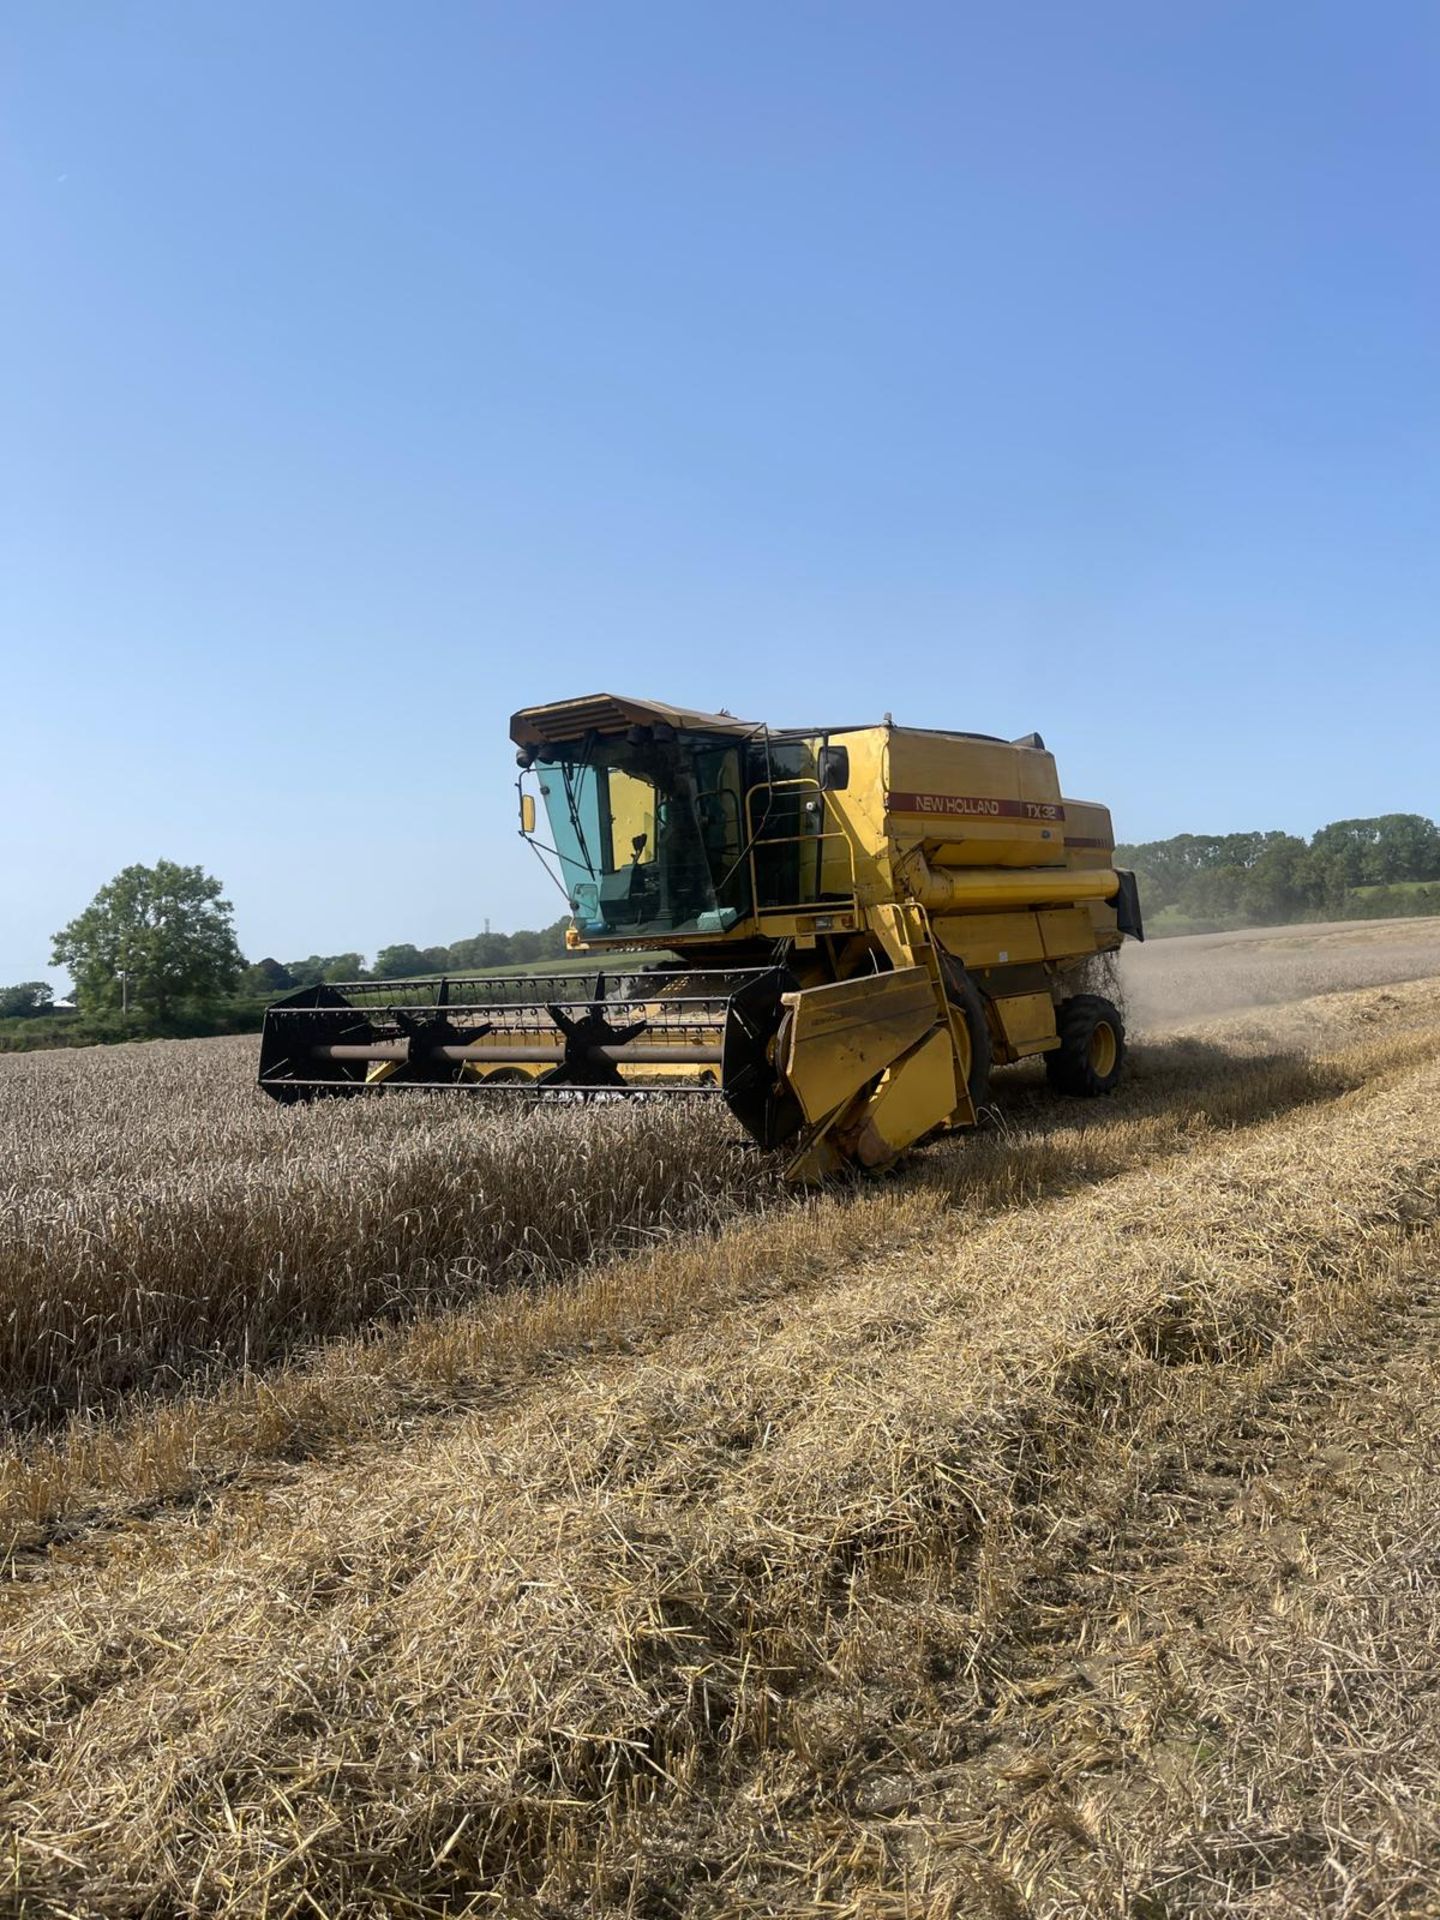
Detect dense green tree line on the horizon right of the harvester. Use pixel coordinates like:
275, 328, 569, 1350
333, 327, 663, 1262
1116, 814, 1440, 933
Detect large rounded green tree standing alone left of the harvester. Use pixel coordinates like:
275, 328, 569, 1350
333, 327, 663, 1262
52, 860, 244, 1021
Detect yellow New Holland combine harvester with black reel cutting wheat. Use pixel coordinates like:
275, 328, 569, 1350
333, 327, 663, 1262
259, 693, 1144, 1179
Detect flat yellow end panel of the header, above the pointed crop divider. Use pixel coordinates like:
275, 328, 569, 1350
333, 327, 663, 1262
783, 968, 940, 1125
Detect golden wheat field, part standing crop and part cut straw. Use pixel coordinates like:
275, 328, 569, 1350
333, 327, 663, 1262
0, 922, 1440, 1920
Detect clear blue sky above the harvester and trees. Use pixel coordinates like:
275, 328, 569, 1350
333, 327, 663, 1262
0, 0, 1440, 981
